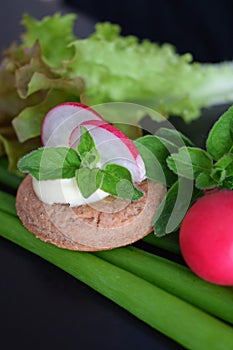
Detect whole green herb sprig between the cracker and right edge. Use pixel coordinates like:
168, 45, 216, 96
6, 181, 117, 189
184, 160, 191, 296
135, 106, 233, 236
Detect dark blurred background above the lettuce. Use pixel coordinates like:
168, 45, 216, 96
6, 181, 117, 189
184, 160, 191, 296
0, 0, 233, 62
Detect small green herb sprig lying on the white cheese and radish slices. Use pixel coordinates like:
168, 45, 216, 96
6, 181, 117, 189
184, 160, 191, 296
18, 126, 143, 200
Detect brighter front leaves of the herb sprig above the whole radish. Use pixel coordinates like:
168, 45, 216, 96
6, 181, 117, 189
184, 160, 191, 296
167, 107, 233, 190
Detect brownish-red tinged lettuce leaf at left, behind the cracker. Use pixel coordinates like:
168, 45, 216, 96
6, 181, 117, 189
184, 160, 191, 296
0, 23, 84, 172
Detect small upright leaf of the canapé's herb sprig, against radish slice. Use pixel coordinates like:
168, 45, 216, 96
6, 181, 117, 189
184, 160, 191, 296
77, 126, 100, 168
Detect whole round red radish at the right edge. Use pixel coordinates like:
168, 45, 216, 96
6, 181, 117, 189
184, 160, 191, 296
180, 190, 233, 286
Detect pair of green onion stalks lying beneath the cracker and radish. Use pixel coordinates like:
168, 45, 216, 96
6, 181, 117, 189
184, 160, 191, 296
0, 192, 233, 349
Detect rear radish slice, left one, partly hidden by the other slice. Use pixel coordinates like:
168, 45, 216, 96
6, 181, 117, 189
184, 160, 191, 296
41, 102, 103, 147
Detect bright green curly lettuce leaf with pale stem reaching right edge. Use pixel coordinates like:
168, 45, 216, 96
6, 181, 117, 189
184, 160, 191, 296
19, 14, 233, 122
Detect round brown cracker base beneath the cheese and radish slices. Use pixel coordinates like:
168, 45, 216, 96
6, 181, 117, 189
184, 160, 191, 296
16, 175, 166, 251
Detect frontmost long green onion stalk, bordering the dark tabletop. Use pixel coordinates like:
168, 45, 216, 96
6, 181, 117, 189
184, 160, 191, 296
0, 211, 233, 349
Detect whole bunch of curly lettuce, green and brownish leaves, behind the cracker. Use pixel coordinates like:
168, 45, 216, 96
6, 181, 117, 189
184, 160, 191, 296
0, 13, 233, 171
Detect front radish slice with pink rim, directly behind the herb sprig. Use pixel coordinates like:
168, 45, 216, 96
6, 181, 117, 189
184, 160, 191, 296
69, 120, 146, 182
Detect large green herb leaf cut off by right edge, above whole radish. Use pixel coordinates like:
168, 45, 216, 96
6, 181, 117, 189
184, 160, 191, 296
206, 107, 233, 160
